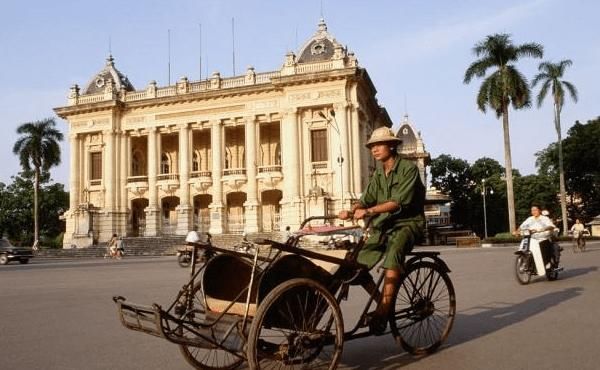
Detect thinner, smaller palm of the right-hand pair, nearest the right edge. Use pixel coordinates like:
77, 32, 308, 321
531, 59, 577, 235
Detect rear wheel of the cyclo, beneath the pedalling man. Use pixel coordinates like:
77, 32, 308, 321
390, 261, 456, 355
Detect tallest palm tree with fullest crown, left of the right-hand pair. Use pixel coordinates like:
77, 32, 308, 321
463, 34, 544, 230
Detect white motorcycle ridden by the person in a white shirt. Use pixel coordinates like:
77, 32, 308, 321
515, 230, 563, 285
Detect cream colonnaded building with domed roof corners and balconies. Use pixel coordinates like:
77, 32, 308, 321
55, 20, 392, 247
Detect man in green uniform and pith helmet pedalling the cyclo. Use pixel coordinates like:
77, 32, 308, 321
338, 127, 425, 333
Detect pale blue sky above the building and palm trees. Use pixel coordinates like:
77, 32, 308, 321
0, 0, 600, 186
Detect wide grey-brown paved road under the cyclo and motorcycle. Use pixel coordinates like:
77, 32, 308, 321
0, 242, 600, 370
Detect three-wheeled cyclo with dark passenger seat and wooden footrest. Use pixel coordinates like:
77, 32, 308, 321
113, 216, 456, 369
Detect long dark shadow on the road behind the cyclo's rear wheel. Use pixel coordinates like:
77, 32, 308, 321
449, 286, 580, 346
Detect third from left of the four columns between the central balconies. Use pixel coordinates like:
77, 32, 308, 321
208, 120, 225, 234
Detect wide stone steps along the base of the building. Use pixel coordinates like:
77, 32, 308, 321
36, 232, 283, 258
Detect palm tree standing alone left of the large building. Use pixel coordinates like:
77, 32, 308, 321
13, 118, 63, 247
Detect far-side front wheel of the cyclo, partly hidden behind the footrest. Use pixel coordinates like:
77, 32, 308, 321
179, 285, 244, 370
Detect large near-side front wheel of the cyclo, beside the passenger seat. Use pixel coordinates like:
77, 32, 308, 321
248, 279, 344, 369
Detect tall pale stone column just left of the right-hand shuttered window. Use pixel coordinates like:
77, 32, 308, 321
281, 108, 302, 230
